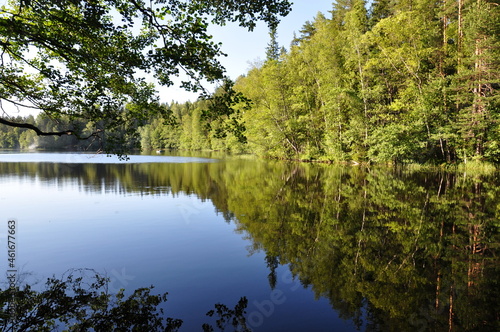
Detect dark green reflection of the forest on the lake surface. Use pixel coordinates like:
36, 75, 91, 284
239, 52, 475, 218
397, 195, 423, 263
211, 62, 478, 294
0, 160, 500, 331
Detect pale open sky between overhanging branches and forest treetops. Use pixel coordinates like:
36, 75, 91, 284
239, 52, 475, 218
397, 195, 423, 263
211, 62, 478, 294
160, 0, 333, 102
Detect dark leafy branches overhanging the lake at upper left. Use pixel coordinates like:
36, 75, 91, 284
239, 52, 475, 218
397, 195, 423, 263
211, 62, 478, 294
0, 0, 291, 154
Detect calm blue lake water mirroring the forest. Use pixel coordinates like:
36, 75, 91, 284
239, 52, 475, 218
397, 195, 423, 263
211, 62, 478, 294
0, 152, 500, 332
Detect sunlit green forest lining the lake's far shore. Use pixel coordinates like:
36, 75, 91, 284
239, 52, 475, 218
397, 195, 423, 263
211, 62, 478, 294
0, 0, 500, 164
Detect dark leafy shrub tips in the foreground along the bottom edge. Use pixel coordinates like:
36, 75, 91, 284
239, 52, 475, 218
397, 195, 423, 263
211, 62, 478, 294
0, 269, 250, 332
